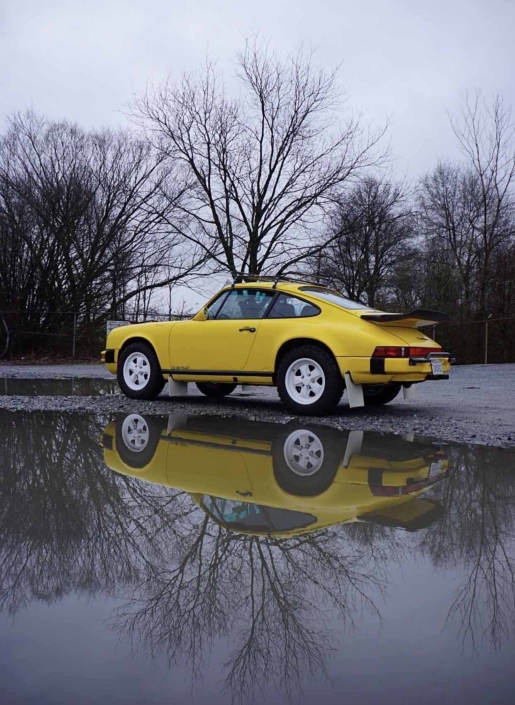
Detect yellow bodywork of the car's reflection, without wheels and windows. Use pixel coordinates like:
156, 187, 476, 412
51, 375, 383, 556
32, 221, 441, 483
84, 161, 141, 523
104, 420, 448, 535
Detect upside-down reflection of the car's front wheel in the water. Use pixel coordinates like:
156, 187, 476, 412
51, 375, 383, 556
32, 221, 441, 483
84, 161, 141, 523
116, 414, 167, 470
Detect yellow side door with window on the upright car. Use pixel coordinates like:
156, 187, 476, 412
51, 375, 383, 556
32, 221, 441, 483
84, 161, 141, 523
170, 288, 274, 373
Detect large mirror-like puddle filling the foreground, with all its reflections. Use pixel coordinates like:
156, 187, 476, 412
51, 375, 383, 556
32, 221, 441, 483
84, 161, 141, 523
0, 412, 515, 704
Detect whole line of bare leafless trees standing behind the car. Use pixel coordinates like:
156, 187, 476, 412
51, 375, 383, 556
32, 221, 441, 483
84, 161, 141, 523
0, 40, 515, 362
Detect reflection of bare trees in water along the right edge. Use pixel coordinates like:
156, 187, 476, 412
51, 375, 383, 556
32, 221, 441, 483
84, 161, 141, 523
416, 446, 515, 649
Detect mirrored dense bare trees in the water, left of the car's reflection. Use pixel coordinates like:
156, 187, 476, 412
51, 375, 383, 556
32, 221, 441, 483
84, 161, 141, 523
0, 413, 190, 613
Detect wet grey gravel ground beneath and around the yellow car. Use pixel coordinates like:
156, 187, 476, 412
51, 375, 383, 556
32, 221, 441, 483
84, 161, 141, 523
0, 364, 515, 446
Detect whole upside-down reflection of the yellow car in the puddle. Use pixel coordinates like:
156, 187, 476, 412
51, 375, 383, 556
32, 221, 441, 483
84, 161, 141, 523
103, 414, 448, 536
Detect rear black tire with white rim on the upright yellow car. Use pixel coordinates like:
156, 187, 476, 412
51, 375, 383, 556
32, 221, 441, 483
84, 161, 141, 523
276, 345, 344, 416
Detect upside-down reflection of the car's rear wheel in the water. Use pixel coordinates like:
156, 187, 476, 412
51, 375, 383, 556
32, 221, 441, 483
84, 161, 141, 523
272, 421, 342, 497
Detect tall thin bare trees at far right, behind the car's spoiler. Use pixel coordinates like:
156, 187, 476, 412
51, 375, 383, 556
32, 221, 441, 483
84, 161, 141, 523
418, 93, 515, 362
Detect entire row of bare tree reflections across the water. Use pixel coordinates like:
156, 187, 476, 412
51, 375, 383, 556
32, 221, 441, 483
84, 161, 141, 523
0, 413, 515, 701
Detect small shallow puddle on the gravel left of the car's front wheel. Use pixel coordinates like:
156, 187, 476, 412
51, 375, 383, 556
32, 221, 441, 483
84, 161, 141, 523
0, 377, 119, 397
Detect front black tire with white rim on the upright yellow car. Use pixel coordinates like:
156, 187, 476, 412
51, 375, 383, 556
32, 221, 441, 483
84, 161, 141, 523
116, 342, 165, 399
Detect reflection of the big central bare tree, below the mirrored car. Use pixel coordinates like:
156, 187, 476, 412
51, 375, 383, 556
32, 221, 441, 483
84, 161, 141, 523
115, 517, 389, 698
